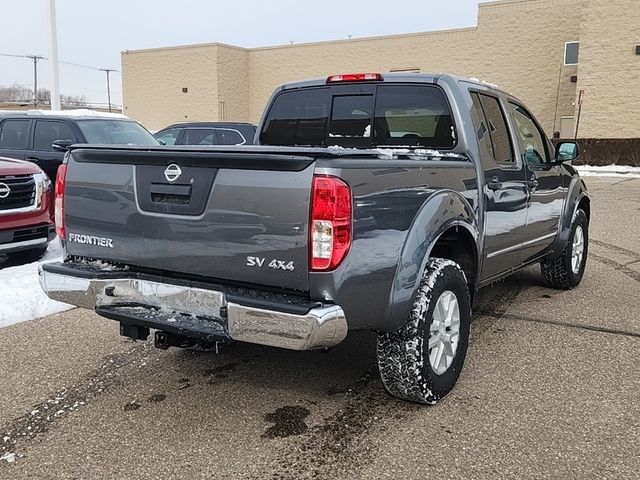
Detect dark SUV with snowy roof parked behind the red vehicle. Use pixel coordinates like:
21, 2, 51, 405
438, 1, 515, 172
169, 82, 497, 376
0, 110, 158, 181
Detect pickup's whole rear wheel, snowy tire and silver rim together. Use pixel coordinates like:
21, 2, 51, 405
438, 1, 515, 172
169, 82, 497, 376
377, 258, 471, 404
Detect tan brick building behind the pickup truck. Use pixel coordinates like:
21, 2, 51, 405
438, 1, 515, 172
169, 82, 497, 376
122, 0, 640, 138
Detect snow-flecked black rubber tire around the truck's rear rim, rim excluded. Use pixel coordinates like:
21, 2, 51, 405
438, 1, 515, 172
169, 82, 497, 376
377, 258, 471, 404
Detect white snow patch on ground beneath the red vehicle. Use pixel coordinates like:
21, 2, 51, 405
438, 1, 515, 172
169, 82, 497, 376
0, 239, 73, 328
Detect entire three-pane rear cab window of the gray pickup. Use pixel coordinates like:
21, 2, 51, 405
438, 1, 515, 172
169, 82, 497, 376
260, 84, 456, 150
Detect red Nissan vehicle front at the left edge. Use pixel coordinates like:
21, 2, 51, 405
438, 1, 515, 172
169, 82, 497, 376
0, 157, 55, 260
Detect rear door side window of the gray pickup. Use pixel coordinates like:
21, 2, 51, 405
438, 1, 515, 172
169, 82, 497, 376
471, 92, 514, 165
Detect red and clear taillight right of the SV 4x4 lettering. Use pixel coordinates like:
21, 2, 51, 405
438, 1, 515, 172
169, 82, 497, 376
309, 175, 352, 271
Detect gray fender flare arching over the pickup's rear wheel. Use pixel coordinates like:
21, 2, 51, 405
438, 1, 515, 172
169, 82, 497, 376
385, 190, 478, 331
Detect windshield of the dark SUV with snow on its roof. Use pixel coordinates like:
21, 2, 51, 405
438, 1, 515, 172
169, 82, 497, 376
77, 120, 158, 146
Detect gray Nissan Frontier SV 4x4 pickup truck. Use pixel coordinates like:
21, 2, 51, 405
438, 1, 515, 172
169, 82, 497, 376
40, 74, 590, 403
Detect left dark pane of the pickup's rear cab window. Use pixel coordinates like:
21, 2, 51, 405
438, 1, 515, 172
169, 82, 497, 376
260, 88, 331, 147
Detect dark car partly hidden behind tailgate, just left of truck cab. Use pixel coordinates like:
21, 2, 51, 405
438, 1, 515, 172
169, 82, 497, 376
154, 122, 256, 145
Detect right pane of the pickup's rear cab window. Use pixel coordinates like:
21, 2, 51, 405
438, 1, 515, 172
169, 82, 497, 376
375, 85, 456, 149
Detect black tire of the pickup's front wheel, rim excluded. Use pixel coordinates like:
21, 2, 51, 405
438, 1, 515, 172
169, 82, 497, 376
540, 210, 589, 290
